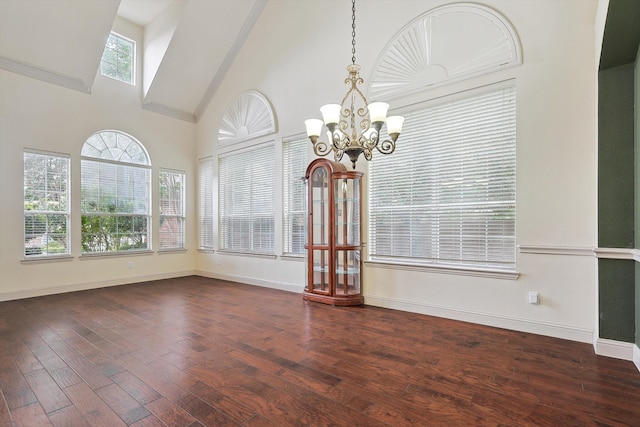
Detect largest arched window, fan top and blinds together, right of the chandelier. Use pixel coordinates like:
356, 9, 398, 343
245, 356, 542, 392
368, 3, 522, 277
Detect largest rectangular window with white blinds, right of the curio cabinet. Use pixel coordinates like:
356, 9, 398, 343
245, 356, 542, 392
368, 86, 516, 270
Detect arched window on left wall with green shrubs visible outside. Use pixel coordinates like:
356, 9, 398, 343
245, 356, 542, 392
81, 130, 151, 254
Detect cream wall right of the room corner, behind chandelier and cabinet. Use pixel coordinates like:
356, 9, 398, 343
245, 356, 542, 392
197, 0, 597, 342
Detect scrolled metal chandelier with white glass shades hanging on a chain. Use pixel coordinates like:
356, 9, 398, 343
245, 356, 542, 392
305, 0, 404, 169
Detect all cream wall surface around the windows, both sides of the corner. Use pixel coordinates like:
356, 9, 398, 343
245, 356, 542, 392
0, 0, 597, 342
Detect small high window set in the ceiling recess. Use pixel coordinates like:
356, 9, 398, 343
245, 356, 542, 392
100, 33, 135, 84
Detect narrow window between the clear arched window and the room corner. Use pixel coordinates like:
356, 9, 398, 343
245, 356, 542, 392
158, 170, 186, 249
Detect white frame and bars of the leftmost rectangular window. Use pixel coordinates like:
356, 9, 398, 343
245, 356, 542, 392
22, 149, 71, 261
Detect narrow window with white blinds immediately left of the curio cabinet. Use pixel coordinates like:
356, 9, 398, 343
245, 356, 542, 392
282, 137, 309, 255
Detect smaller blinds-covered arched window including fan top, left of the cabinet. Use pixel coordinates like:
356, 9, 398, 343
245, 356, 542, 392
218, 91, 275, 254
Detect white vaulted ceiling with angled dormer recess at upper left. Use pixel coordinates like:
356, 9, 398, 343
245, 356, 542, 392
0, 0, 267, 122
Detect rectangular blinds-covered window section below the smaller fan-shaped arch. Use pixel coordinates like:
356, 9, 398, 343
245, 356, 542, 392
218, 143, 275, 254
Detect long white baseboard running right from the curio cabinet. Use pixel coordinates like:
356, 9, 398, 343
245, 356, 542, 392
364, 295, 593, 343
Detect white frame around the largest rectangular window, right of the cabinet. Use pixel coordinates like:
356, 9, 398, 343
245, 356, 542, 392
367, 79, 518, 279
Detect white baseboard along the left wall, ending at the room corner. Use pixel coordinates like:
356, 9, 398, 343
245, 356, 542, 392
0, 270, 197, 302
